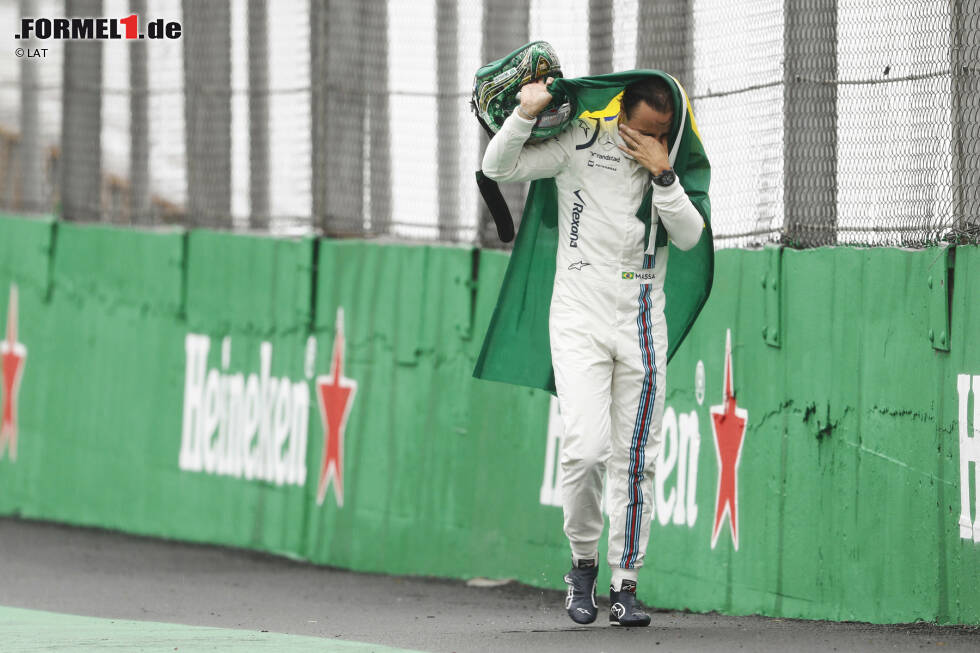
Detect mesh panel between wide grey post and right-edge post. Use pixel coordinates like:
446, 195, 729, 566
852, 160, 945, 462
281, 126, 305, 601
829, 0, 953, 245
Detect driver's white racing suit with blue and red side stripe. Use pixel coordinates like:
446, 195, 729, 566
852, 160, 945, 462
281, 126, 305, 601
483, 111, 704, 590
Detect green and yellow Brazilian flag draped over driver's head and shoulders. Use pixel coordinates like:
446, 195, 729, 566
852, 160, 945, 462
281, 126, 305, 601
473, 70, 714, 393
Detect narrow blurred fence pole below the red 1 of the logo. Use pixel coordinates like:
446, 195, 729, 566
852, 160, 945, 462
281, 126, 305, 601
129, 0, 153, 225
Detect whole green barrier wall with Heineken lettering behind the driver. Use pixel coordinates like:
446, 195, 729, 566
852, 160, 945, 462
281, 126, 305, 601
0, 211, 980, 624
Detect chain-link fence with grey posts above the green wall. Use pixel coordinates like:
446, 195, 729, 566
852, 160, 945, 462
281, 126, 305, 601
0, 0, 980, 247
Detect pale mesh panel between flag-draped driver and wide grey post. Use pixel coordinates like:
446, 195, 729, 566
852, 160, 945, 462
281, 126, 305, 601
675, 0, 784, 246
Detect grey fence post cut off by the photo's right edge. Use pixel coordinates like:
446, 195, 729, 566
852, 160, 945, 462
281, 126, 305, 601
950, 0, 980, 242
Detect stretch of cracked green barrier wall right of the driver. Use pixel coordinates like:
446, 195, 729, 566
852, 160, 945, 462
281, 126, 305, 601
648, 248, 980, 623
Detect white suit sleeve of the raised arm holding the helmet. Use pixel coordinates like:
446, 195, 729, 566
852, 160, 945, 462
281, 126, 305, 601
483, 110, 572, 182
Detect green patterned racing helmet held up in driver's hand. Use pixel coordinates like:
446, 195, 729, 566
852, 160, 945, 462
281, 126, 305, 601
470, 41, 572, 142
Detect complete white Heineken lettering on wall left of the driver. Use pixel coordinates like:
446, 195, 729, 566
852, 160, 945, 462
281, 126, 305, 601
179, 333, 310, 485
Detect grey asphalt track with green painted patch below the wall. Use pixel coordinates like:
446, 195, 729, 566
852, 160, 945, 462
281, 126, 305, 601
0, 519, 980, 653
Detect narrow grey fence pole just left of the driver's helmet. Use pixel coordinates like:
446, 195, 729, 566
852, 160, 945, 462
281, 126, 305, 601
436, 0, 461, 241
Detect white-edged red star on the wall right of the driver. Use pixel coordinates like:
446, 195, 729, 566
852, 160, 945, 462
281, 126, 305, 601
711, 329, 749, 551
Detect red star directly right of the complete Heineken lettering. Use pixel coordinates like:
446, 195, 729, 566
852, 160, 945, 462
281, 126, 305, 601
316, 308, 357, 506
